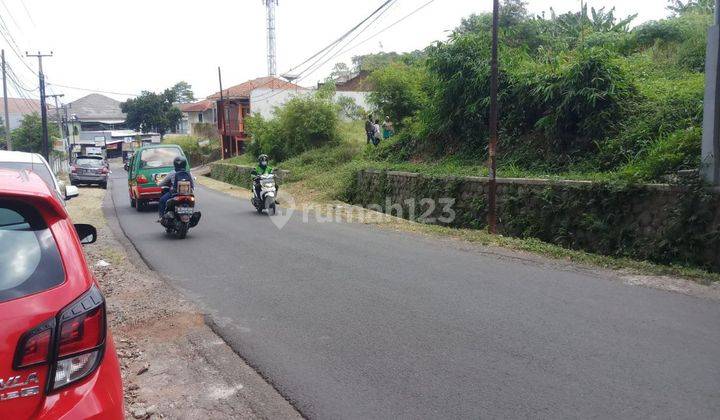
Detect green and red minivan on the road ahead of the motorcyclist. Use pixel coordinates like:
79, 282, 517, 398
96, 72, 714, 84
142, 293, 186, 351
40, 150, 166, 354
128, 144, 190, 211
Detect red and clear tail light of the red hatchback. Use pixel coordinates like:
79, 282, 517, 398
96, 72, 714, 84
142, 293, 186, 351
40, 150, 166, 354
13, 286, 107, 392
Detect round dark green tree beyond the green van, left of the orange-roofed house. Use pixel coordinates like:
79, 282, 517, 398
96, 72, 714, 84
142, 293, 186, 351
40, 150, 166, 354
120, 90, 182, 137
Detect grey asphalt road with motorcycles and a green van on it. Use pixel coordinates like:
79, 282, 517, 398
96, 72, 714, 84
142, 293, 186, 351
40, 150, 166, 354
107, 169, 720, 419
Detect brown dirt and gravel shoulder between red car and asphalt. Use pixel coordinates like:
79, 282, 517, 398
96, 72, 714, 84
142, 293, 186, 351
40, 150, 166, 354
62, 188, 301, 419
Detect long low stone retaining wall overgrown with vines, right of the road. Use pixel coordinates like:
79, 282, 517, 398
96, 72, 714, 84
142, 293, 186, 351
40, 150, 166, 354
348, 170, 720, 271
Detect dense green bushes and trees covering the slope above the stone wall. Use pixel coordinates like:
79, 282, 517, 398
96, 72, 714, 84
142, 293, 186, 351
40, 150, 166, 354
239, 0, 712, 185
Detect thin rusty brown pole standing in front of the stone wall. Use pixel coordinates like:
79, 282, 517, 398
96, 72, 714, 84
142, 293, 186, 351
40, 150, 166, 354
488, 0, 500, 235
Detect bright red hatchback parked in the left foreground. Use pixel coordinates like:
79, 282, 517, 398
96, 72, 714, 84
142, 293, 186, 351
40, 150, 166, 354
0, 170, 124, 419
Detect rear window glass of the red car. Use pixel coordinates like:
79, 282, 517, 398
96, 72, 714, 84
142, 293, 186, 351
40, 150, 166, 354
0, 199, 65, 302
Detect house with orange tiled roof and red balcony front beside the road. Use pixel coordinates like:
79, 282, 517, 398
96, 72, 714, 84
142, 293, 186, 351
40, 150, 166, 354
207, 76, 309, 159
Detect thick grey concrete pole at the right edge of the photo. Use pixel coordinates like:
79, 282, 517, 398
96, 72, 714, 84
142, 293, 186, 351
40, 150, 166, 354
700, 0, 720, 185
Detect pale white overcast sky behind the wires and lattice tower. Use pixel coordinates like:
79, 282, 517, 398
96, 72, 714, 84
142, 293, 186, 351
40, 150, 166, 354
0, 0, 668, 102
